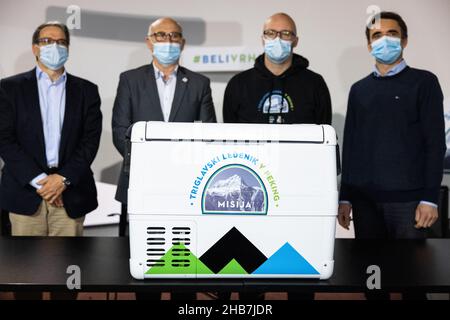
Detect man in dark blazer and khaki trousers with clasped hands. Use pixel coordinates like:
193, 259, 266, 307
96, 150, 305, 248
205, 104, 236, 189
0, 22, 102, 236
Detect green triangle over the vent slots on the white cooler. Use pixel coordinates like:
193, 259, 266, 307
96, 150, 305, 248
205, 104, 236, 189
145, 244, 214, 274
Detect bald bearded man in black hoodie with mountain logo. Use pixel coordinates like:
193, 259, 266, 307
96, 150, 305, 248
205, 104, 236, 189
223, 13, 331, 300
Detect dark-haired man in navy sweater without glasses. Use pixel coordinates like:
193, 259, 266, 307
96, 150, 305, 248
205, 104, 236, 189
338, 12, 446, 298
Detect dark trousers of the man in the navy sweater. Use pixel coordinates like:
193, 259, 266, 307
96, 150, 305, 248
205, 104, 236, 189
352, 198, 426, 300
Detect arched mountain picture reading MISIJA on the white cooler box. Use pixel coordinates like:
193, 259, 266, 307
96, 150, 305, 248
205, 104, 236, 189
204, 166, 266, 213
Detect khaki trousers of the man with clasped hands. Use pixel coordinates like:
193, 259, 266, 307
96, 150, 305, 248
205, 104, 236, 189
9, 200, 84, 237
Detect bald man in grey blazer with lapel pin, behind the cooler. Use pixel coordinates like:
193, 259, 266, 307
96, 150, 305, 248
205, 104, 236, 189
112, 18, 216, 298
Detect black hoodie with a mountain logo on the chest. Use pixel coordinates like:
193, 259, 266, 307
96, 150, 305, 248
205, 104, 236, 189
223, 54, 331, 124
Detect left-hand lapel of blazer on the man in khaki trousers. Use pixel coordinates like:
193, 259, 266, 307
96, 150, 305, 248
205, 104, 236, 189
25, 68, 47, 166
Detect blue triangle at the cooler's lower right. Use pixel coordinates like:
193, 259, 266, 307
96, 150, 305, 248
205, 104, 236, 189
253, 242, 319, 274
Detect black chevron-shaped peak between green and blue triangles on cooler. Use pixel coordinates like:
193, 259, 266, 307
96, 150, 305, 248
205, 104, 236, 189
200, 227, 267, 273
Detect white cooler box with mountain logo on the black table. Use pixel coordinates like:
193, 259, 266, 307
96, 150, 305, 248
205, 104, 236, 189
128, 122, 338, 279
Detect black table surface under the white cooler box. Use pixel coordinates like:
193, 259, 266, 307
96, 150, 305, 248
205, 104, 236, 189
0, 237, 450, 292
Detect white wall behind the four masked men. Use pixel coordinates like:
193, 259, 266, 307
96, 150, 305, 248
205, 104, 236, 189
0, 0, 450, 182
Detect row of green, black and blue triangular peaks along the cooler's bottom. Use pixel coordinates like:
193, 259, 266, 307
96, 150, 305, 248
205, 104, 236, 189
146, 227, 320, 275
